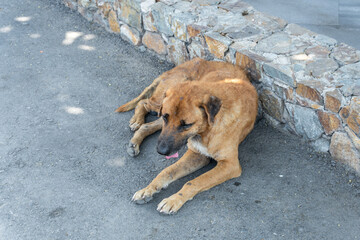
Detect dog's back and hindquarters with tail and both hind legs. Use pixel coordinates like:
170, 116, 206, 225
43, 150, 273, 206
116, 58, 247, 157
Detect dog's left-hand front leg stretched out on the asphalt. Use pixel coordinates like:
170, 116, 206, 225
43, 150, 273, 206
132, 150, 210, 204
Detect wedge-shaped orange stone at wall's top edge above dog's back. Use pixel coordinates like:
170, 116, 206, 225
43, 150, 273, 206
204, 32, 232, 59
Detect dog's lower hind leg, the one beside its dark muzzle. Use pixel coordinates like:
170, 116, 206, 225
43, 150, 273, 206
127, 118, 163, 157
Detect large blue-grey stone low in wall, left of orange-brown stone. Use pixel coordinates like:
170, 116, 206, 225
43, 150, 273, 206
285, 103, 323, 140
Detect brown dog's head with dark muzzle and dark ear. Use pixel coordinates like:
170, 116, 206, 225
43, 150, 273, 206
157, 84, 221, 155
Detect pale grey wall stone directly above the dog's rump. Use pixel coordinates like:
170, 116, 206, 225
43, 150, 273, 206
168, 38, 189, 65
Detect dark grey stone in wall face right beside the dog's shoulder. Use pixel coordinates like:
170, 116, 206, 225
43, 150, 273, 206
259, 89, 284, 122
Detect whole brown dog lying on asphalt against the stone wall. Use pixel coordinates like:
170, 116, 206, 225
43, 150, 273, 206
117, 59, 258, 214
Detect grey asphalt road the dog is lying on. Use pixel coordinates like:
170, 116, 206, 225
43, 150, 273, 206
0, 0, 360, 240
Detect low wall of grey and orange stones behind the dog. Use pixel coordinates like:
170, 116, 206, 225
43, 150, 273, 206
63, 0, 360, 172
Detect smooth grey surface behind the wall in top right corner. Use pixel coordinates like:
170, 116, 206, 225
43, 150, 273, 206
243, 0, 360, 49
